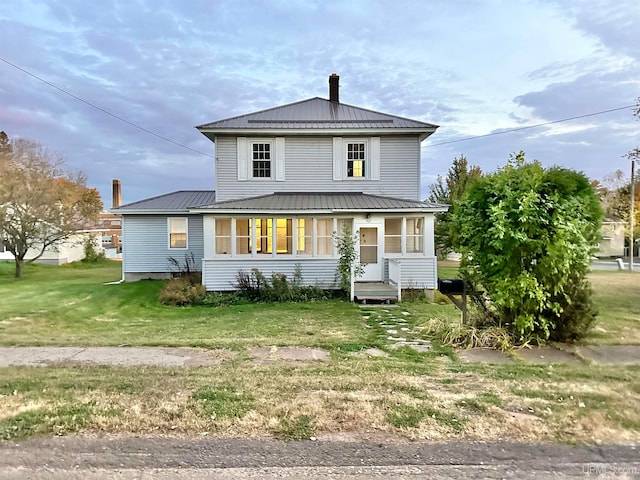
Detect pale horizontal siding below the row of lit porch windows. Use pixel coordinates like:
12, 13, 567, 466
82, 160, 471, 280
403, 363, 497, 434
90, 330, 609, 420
202, 257, 338, 291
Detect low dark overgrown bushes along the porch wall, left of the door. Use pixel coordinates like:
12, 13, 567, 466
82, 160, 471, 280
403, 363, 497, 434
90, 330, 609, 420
234, 266, 328, 302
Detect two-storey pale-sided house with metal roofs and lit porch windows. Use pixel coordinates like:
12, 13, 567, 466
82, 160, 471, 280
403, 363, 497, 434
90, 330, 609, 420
112, 74, 447, 300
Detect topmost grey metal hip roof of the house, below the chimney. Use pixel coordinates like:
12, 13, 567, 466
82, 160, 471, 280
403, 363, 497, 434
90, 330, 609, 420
196, 97, 438, 133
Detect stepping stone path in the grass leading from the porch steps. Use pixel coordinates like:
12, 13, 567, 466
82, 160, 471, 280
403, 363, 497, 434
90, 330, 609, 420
360, 305, 431, 356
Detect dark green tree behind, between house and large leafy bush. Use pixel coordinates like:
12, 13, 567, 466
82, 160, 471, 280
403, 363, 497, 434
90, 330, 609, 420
429, 155, 482, 253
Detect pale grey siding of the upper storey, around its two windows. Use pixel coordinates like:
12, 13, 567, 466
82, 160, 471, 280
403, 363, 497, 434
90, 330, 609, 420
216, 135, 420, 201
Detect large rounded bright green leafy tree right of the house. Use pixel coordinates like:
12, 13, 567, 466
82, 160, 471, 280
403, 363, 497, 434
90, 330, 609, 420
453, 152, 602, 341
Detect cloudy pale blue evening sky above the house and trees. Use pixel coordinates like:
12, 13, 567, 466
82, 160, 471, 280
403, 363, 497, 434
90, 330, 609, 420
0, 0, 640, 208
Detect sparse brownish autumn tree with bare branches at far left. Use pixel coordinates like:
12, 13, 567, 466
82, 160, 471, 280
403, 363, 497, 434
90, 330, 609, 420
0, 138, 102, 278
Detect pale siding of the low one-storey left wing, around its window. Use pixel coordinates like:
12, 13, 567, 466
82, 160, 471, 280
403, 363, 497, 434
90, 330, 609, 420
122, 215, 204, 273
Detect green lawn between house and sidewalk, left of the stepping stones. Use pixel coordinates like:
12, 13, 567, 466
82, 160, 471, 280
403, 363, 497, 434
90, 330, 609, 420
0, 264, 370, 349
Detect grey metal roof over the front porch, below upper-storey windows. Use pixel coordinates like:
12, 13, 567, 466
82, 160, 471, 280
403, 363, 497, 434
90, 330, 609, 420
192, 192, 448, 212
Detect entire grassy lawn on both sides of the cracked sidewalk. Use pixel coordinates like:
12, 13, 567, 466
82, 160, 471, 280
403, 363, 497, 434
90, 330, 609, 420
0, 263, 640, 443
